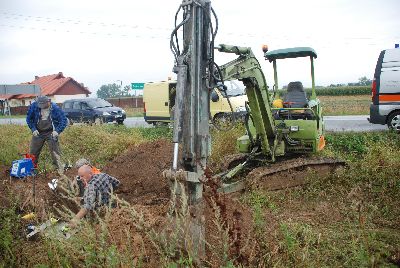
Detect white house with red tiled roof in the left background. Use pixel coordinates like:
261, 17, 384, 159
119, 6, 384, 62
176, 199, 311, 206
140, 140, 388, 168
0, 72, 91, 107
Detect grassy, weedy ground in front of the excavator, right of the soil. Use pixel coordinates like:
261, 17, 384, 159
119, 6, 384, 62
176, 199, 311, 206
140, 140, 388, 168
239, 132, 400, 267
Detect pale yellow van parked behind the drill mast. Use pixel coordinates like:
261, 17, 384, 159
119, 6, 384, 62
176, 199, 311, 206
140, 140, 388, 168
143, 81, 247, 125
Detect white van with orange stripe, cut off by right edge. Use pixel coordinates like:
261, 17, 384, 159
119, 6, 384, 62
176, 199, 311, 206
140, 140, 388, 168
368, 45, 400, 132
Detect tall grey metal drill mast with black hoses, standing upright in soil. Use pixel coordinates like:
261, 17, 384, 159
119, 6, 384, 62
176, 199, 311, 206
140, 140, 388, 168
171, 0, 213, 204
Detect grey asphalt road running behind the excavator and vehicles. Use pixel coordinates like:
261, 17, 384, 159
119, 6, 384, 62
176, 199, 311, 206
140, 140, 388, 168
0, 115, 387, 132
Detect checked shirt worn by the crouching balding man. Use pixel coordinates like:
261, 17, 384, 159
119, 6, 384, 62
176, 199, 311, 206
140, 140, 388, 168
83, 173, 119, 210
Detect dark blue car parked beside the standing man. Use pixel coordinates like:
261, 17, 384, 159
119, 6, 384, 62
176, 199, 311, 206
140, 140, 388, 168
62, 98, 126, 124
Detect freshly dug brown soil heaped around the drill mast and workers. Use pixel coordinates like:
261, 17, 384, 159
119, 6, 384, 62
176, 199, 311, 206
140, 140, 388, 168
0, 140, 256, 267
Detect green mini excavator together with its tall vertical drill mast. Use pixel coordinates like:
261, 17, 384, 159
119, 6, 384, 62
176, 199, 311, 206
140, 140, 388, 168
166, 0, 340, 197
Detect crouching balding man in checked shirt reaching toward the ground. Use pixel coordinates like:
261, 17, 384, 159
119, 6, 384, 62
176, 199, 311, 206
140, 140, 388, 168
69, 165, 120, 227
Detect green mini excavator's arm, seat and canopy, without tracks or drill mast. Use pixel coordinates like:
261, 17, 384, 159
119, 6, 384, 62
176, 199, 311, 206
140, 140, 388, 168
217, 45, 325, 185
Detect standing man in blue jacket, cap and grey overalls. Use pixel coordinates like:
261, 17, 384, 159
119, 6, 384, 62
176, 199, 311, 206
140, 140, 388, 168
26, 96, 67, 174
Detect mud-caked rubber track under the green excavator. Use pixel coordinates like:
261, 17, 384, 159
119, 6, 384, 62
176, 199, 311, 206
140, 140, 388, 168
220, 158, 346, 193
